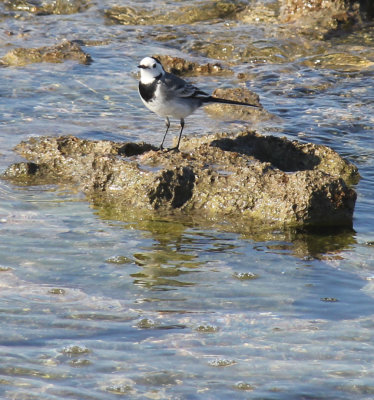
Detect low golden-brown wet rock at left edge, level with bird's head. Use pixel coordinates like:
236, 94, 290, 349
0, 41, 92, 67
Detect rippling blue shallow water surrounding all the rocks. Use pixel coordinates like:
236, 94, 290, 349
0, 0, 374, 400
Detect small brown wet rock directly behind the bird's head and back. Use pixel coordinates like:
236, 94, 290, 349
154, 55, 233, 75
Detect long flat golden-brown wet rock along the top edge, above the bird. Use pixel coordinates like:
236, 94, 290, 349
105, 0, 244, 25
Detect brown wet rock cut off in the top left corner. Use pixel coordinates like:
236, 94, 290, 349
4, 0, 90, 15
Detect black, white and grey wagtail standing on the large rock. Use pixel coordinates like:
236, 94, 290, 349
138, 57, 258, 150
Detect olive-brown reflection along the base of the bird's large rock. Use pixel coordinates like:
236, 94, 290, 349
96, 204, 356, 264
